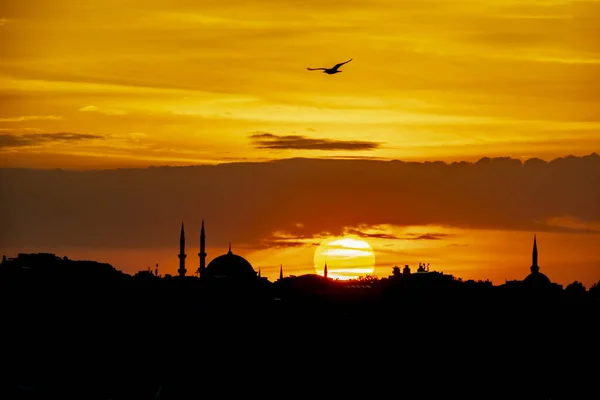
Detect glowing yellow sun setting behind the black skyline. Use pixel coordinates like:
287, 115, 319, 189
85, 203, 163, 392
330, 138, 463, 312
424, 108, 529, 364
314, 237, 375, 280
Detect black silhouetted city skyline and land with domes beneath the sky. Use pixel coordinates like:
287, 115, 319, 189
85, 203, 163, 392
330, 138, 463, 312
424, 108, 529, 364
0, 228, 600, 399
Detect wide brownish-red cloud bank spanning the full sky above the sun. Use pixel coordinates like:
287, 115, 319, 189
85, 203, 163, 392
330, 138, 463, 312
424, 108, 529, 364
0, 154, 600, 248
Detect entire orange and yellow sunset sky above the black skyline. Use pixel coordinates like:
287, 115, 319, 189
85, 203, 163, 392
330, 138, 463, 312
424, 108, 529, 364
0, 0, 600, 287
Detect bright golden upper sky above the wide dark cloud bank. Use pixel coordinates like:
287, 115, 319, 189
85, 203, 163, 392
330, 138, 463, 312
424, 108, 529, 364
0, 0, 600, 168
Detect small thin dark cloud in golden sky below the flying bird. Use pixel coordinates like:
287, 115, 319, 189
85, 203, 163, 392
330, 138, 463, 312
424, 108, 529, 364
250, 133, 381, 151
